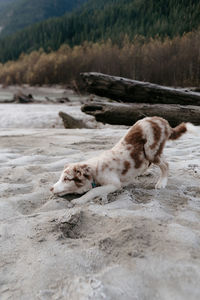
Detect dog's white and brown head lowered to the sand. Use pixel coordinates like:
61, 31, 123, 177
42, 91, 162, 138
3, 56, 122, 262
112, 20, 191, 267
51, 163, 92, 196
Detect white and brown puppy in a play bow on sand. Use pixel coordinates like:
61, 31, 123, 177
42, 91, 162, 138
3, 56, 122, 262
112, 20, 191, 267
51, 117, 197, 204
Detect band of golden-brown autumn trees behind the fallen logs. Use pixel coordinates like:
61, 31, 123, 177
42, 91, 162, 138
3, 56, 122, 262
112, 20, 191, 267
0, 30, 200, 86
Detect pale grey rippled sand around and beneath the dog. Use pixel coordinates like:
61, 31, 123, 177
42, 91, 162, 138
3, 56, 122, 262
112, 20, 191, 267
0, 85, 200, 300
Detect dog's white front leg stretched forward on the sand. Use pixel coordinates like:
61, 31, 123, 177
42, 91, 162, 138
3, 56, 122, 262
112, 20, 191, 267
71, 184, 120, 204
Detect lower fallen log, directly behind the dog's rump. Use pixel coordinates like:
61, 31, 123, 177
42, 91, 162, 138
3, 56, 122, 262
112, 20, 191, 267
81, 103, 200, 127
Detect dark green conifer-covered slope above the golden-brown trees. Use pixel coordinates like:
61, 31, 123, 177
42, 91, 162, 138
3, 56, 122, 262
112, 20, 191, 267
0, 0, 200, 62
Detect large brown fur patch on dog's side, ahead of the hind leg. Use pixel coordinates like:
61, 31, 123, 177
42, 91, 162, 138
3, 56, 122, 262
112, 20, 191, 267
124, 124, 146, 169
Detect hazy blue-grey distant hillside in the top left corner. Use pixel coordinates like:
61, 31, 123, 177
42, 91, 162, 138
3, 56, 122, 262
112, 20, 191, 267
0, 0, 87, 36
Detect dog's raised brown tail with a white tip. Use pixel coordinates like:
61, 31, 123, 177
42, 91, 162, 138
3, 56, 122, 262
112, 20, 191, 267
169, 122, 199, 140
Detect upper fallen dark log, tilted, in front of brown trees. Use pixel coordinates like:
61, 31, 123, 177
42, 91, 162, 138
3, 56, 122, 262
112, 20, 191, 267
81, 73, 200, 105
